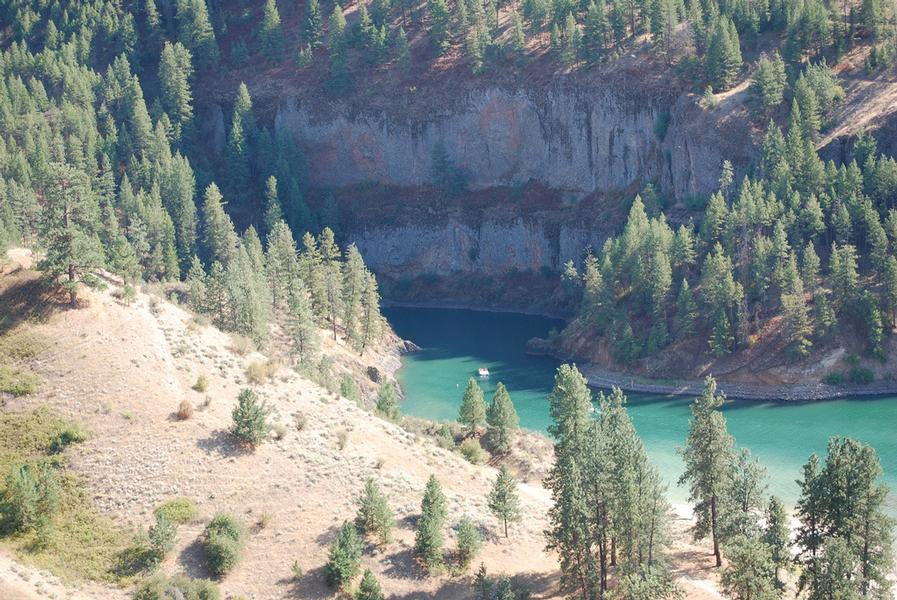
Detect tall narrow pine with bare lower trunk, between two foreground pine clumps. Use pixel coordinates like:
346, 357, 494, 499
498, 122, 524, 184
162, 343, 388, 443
679, 375, 734, 567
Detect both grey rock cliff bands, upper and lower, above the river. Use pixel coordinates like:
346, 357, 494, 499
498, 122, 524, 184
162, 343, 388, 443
264, 88, 751, 284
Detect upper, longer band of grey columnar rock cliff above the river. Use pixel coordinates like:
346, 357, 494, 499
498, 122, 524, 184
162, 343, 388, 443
275, 88, 750, 197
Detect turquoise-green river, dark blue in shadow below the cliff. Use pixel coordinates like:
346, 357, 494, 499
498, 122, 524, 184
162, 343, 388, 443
384, 307, 897, 514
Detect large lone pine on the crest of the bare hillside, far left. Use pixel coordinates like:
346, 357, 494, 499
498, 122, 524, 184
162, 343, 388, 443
39, 163, 103, 307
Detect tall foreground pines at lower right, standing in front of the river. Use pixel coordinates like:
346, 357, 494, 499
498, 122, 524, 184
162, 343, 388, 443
546, 365, 895, 600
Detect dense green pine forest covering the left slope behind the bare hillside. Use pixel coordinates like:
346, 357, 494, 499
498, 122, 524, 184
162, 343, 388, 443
0, 1, 383, 362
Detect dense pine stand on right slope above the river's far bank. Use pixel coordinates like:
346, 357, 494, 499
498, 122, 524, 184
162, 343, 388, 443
562, 89, 897, 363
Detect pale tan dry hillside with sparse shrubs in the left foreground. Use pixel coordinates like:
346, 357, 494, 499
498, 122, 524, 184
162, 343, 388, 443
0, 247, 714, 600
